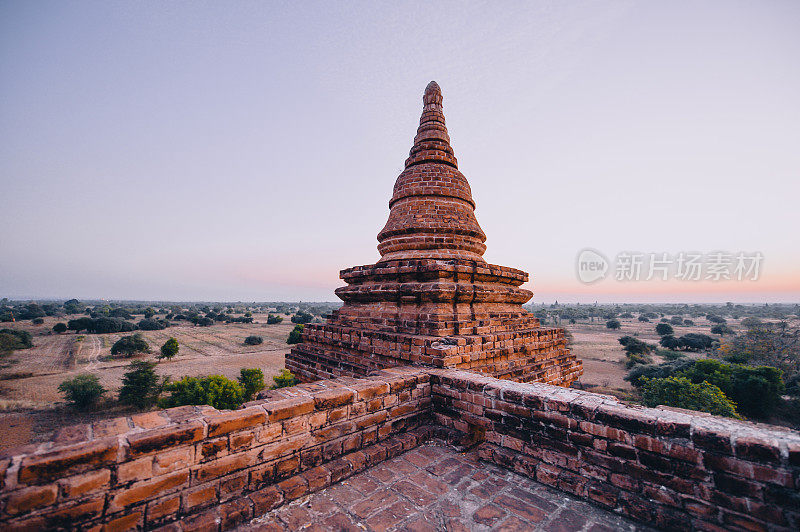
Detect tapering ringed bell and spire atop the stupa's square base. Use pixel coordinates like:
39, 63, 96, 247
378, 81, 486, 262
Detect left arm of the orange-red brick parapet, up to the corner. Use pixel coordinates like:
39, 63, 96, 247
0, 369, 430, 530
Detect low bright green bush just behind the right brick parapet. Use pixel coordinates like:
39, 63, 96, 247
642, 377, 739, 418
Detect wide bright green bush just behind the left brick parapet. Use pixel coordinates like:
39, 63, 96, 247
158, 375, 244, 410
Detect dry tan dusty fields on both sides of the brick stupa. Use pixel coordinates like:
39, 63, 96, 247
0, 314, 752, 450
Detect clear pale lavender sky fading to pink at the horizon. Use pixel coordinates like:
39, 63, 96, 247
0, 0, 800, 302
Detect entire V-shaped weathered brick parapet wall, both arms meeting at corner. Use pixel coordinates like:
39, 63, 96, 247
0, 367, 800, 531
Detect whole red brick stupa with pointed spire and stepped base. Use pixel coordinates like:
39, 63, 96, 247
286, 81, 583, 386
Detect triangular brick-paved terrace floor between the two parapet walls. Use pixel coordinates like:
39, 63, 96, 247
239, 444, 651, 532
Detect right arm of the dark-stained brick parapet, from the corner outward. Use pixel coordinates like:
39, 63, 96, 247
431, 370, 800, 530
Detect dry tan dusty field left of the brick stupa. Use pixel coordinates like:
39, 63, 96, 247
0, 315, 294, 450
